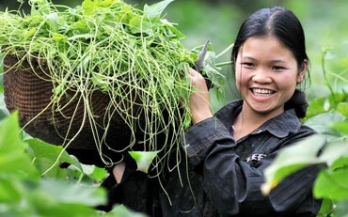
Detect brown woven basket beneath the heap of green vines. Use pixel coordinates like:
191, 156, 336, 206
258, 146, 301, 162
4, 56, 150, 165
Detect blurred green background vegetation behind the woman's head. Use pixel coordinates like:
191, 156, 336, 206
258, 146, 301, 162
0, 0, 348, 109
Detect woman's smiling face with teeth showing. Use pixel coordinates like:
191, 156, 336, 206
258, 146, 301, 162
235, 36, 307, 117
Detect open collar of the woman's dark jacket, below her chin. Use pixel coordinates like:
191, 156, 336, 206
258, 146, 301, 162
215, 100, 301, 138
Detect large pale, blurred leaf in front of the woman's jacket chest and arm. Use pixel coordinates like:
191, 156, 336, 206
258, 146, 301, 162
262, 134, 325, 194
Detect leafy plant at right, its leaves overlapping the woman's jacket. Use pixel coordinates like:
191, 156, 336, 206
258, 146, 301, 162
263, 46, 348, 217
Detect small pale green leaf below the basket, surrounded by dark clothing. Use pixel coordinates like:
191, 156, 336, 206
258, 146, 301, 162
129, 151, 158, 173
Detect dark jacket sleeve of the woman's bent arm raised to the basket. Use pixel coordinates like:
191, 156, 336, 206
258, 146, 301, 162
183, 118, 317, 216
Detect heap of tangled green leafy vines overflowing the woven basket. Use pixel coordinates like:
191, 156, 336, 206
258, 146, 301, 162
0, 0, 224, 170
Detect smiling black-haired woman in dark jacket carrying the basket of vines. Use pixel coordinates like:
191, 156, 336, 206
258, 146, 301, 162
106, 7, 321, 217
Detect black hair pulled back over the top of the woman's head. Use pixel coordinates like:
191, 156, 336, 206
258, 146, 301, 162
231, 6, 308, 73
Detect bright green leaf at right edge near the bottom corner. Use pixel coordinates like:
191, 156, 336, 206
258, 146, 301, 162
313, 167, 348, 201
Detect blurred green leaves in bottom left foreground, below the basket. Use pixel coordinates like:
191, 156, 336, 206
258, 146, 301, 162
0, 112, 150, 217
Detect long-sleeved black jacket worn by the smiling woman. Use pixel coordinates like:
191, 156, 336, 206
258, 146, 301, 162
101, 92, 321, 217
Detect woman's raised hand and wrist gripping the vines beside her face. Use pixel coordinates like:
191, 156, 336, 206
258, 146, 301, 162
188, 68, 213, 124
